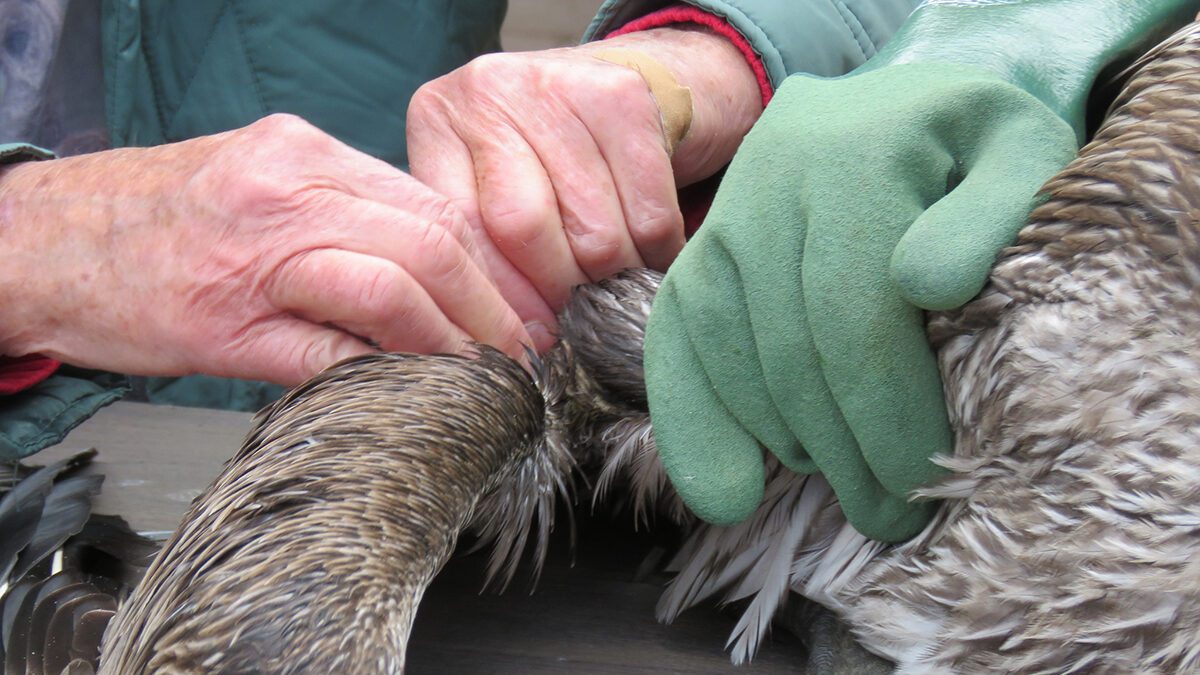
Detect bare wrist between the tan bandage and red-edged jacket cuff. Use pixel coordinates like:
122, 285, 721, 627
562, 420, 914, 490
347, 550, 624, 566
577, 24, 762, 187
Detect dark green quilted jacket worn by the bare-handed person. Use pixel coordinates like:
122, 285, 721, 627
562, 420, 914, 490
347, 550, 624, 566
0, 0, 917, 459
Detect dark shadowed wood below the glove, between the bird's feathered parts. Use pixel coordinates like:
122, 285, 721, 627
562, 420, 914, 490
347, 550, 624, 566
409, 516, 805, 675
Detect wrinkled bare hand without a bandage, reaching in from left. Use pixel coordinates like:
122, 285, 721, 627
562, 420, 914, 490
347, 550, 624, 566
0, 115, 529, 384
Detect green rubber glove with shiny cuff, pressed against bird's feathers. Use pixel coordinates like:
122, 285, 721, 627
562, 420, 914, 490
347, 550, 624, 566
644, 0, 1200, 542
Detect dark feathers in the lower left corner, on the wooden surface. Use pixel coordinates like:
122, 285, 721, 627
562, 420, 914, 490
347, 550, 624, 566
0, 450, 156, 675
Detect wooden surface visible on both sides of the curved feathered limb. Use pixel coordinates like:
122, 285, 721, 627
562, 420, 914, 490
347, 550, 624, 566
35, 402, 804, 675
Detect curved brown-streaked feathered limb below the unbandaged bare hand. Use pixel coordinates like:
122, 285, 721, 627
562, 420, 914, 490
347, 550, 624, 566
101, 350, 542, 674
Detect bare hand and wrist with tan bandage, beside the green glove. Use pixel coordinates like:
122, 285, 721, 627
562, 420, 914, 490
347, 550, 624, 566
408, 28, 762, 348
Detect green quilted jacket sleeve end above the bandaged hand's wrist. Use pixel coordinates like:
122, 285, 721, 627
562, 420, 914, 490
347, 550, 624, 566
584, 0, 919, 88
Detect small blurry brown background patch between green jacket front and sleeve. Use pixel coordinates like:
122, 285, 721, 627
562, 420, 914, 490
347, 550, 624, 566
500, 0, 602, 52
